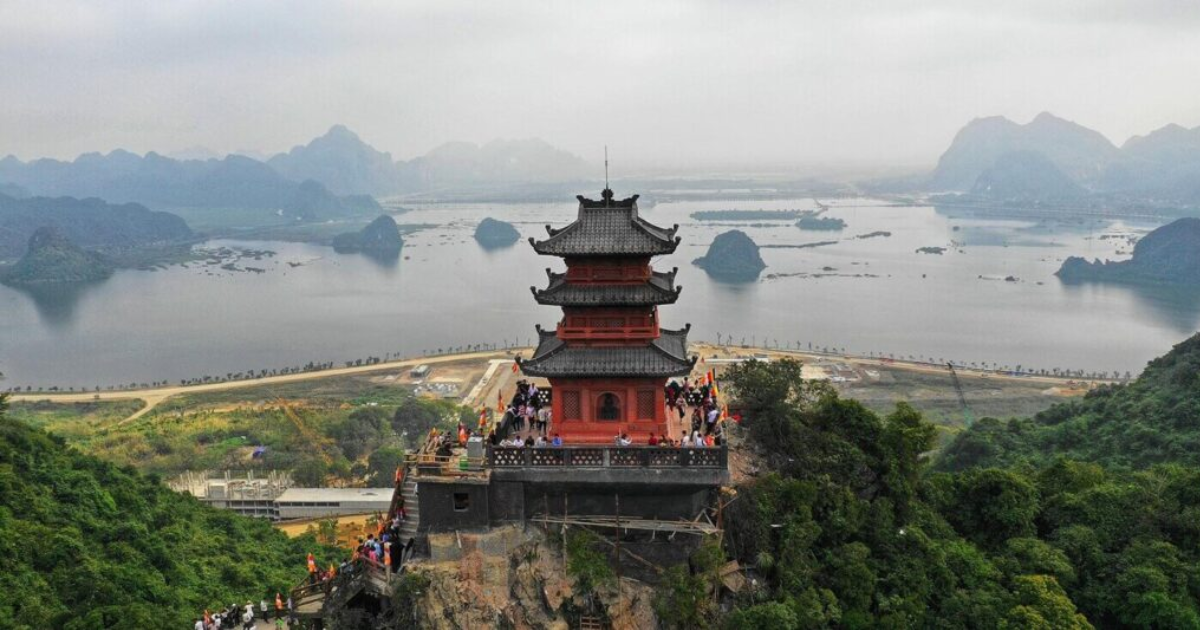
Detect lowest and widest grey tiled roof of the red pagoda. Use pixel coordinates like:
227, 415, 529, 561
517, 326, 696, 378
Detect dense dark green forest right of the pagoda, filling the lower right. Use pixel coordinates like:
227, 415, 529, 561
659, 355, 1200, 630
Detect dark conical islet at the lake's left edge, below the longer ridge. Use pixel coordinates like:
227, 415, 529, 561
0, 227, 113, 287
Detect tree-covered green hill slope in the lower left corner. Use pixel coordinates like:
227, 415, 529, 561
0, 400, 338, 630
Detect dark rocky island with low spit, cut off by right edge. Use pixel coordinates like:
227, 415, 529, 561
1055, 217, 1200, 286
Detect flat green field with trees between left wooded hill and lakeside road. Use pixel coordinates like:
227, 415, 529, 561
12, 376, 474, 485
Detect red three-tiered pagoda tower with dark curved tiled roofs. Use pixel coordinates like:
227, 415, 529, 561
517, 188, 696, 444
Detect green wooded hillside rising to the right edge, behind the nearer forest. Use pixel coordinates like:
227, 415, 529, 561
937, 335, 1200, 470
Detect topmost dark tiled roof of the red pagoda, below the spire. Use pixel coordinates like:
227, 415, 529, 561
529, 191, 679, 256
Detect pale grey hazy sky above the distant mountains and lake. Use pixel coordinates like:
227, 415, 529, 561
0, 0, 1200, 172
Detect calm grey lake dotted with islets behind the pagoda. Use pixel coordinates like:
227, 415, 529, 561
0, 198, 1200, 389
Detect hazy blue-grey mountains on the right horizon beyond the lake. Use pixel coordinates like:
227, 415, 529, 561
928, 113, 1200, 205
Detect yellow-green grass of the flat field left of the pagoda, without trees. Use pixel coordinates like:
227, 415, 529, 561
12, 374, 468, 480
